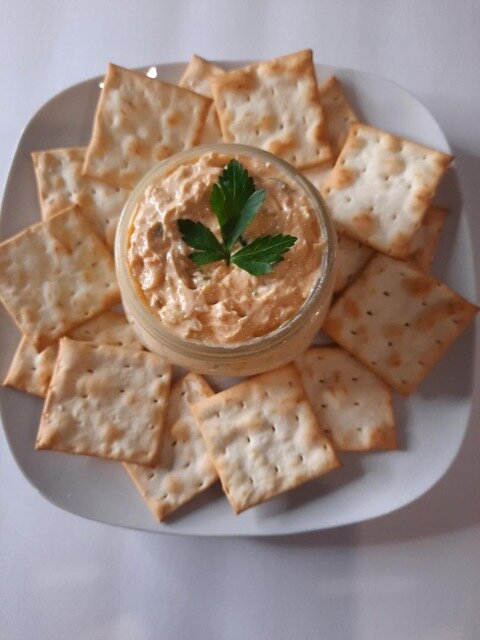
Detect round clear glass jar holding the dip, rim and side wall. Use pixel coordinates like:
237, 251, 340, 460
115, 144, 336, 376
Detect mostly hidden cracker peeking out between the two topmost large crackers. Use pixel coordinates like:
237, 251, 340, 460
178, 55, 225, 144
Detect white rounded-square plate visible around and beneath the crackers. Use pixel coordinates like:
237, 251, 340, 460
0, 63, 475, 536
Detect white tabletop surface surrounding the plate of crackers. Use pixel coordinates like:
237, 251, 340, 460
0, 0, 480, 640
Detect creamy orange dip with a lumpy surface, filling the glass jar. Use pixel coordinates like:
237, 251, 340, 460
128, 153, 323, 345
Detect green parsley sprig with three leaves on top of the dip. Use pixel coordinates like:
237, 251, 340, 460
177, 160, 297, 276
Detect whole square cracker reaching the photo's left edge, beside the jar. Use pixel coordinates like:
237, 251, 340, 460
0, 207, 120, 351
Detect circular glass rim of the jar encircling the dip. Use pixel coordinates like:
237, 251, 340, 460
114, 143, 336, 361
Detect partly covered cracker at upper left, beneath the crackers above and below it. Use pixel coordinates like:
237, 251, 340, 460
32, 147, 129, 249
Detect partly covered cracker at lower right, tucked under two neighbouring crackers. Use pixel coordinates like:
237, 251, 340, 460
295, 347, 397, 451
